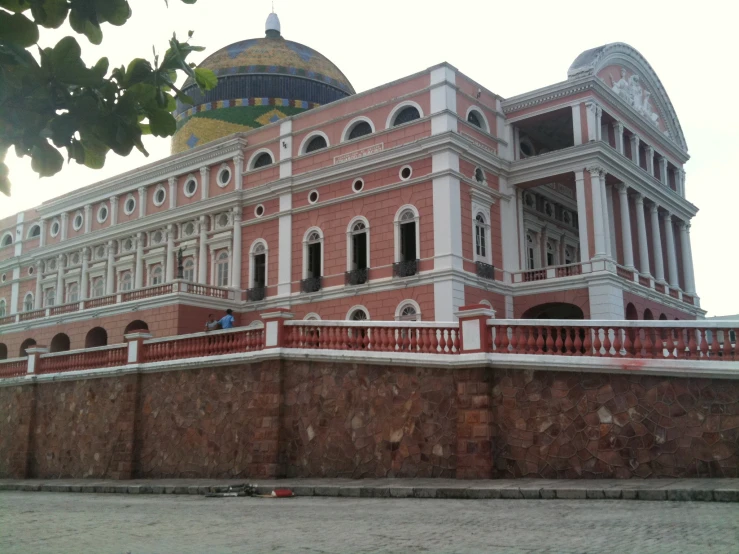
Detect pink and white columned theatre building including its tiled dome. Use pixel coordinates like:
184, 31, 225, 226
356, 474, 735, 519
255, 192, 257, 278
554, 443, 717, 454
0, 15, 704, 358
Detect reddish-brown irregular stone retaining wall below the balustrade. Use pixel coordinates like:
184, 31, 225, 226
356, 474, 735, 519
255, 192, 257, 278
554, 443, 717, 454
0, 360, 739, 479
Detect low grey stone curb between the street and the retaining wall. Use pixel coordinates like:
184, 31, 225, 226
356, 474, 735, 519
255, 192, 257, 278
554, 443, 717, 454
0, 483, 739, 502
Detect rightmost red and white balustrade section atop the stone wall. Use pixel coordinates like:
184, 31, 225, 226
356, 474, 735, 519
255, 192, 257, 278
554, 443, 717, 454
491, 320, 739, 361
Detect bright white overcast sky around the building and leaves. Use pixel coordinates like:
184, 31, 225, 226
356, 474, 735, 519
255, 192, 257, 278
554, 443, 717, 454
0, 0, 739, 316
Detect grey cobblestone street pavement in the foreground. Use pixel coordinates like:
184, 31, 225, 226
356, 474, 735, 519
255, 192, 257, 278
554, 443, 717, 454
0, 492, 739, 554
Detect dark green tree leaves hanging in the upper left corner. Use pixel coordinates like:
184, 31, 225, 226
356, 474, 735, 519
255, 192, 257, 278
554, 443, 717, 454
0, 0, 217, 194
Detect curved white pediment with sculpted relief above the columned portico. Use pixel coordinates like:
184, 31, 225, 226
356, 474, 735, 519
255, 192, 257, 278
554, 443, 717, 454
567, 42, 687, 151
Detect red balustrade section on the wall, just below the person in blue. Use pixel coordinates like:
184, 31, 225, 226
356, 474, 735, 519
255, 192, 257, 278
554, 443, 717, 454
143, 329, 264, 362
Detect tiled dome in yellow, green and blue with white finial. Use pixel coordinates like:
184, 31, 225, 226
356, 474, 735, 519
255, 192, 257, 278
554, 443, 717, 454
172, 14, 354, 154
